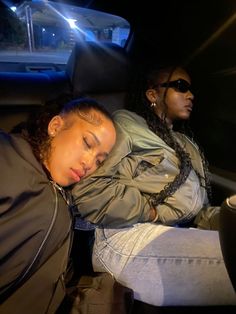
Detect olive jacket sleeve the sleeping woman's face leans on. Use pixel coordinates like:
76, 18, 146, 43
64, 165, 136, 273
72, 113, 150, 227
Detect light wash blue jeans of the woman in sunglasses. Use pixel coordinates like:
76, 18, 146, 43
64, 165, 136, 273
93, 223, 236, 306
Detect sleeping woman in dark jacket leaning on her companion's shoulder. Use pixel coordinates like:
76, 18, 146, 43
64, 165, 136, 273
0, 99, 116, 314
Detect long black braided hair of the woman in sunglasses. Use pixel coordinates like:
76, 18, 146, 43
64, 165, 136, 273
126, 66, 211, 206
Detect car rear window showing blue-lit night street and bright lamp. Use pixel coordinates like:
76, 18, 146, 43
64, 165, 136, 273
0, 1, 130, 64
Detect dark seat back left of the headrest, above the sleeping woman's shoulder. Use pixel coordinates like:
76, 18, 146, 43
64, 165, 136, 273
0, 70, 71, 131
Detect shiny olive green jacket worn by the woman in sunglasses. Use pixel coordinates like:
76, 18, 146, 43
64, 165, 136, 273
72, 110, 208, 227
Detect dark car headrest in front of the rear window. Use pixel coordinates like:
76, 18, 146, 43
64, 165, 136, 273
66, 42, 129, 96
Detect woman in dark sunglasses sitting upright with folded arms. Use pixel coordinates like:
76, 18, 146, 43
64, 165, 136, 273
72, 67, 236, 306
